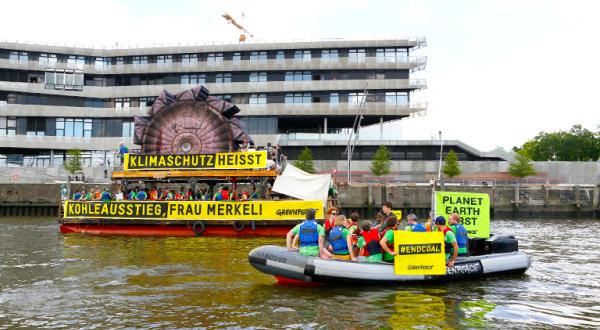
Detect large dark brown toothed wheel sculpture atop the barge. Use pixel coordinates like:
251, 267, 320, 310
134, 86, 251, 154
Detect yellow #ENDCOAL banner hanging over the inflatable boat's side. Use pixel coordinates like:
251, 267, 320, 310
394, 230, 446, 275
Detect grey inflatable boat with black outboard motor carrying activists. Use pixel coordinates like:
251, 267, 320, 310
248, 236, 531, 284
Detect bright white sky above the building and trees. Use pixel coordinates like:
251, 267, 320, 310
0, 0, 600, 151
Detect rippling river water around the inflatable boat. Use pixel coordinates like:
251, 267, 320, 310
0, 218, 600, 329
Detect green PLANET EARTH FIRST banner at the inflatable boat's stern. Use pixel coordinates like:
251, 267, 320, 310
435, 191, 490, 238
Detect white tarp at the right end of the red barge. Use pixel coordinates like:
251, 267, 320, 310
273, 163, 331, 206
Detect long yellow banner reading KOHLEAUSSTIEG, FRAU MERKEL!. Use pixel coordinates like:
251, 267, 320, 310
64, 200, 323, 220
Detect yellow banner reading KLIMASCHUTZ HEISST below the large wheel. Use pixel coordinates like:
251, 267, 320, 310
123, 151, 267, 171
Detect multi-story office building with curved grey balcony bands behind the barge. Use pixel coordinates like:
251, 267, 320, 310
0, 38, 500, 166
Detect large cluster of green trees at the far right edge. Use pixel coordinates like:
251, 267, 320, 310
514, 125, 600, 161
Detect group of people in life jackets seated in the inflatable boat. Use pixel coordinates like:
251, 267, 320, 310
286, 202, 468, 267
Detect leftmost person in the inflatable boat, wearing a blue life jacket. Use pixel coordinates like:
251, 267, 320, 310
285, 209, 325, 257
